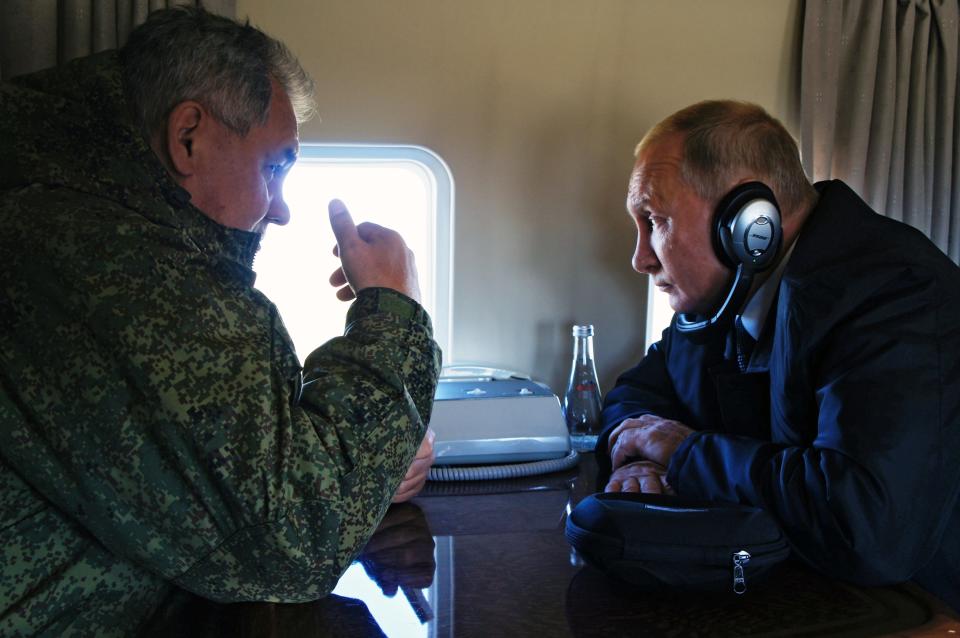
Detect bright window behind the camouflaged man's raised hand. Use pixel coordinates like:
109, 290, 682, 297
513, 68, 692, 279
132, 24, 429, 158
254, 144, 453, 361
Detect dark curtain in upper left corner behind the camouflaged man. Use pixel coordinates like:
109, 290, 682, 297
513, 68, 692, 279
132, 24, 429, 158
0, 0, 236, 79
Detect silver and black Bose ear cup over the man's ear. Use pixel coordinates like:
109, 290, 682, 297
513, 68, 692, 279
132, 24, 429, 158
713, 182, 782, 272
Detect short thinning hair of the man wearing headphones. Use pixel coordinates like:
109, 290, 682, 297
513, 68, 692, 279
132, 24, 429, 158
637, 100, 816, 212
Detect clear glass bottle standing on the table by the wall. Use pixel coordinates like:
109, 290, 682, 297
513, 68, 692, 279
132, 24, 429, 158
563, 326, 601, 452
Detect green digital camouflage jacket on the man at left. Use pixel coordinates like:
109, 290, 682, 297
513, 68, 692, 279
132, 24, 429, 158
0, 52, 440, 635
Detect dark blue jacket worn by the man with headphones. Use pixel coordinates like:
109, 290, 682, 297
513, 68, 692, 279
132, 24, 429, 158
597, 181, 960, 609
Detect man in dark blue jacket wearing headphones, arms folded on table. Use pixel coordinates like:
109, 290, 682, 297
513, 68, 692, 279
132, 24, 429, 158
597, 101, 960, 609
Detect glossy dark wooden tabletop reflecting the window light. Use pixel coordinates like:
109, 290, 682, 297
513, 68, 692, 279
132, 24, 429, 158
148, 454, 960, 638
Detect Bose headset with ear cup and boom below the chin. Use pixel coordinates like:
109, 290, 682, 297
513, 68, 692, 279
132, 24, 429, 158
677, 182, 783, 336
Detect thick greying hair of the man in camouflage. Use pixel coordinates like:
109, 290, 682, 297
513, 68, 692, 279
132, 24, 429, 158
120, 6, 314, 140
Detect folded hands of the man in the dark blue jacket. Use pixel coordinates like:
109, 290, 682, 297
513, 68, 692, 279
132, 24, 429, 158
604, 414, 693, 495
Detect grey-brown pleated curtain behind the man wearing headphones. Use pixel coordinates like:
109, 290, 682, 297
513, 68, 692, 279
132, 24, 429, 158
800, 0, 960, 263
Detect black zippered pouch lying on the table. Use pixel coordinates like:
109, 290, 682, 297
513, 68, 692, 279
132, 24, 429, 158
566, 492, 790, 594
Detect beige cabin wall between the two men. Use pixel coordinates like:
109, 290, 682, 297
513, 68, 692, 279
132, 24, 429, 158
237, 0, 802, 392
